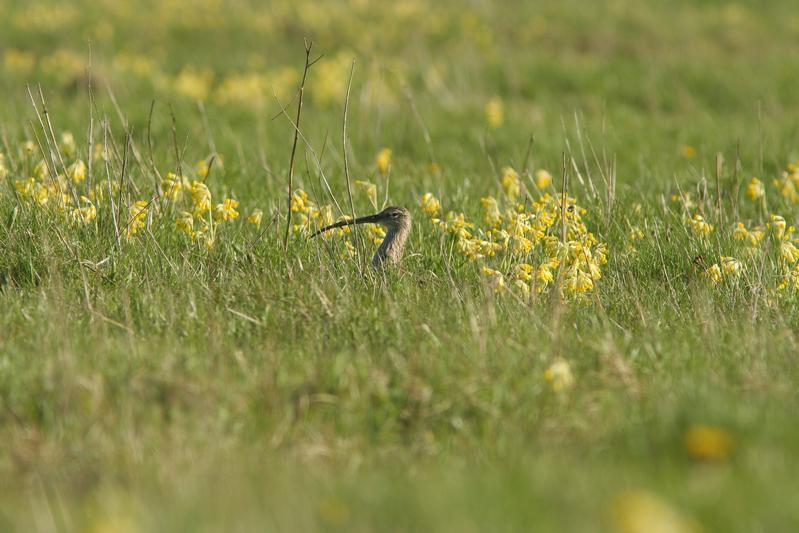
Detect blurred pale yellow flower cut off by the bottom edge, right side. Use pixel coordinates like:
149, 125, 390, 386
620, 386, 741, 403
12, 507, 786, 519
610, 490, 700, 533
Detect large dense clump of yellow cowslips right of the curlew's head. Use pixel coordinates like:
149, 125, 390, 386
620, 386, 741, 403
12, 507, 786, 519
419, 167, 607, 298
